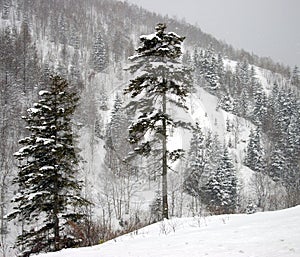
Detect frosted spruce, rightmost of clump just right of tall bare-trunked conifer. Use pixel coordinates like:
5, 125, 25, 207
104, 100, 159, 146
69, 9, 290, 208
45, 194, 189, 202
206, 146, 237, 214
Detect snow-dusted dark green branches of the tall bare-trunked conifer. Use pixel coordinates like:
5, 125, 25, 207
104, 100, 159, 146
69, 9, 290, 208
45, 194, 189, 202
125, 24, 191, 156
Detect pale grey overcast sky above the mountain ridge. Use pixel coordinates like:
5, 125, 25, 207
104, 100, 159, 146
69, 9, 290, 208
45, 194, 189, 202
125, 0, 300, 67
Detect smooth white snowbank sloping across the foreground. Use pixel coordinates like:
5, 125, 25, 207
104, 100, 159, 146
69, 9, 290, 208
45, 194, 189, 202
39, 206, 300, 257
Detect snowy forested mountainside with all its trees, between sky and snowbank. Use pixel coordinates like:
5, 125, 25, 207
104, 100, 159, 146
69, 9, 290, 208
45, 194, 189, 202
0, 0, 300, 257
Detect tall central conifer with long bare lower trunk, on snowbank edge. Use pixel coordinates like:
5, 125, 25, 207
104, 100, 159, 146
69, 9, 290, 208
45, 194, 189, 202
125, 23, 192, 218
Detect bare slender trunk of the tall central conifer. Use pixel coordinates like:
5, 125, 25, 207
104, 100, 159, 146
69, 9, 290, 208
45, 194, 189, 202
162, 93, 169, 219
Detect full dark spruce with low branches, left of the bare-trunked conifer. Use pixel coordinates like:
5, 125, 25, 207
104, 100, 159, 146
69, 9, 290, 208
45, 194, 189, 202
9, 76, 88, 256
